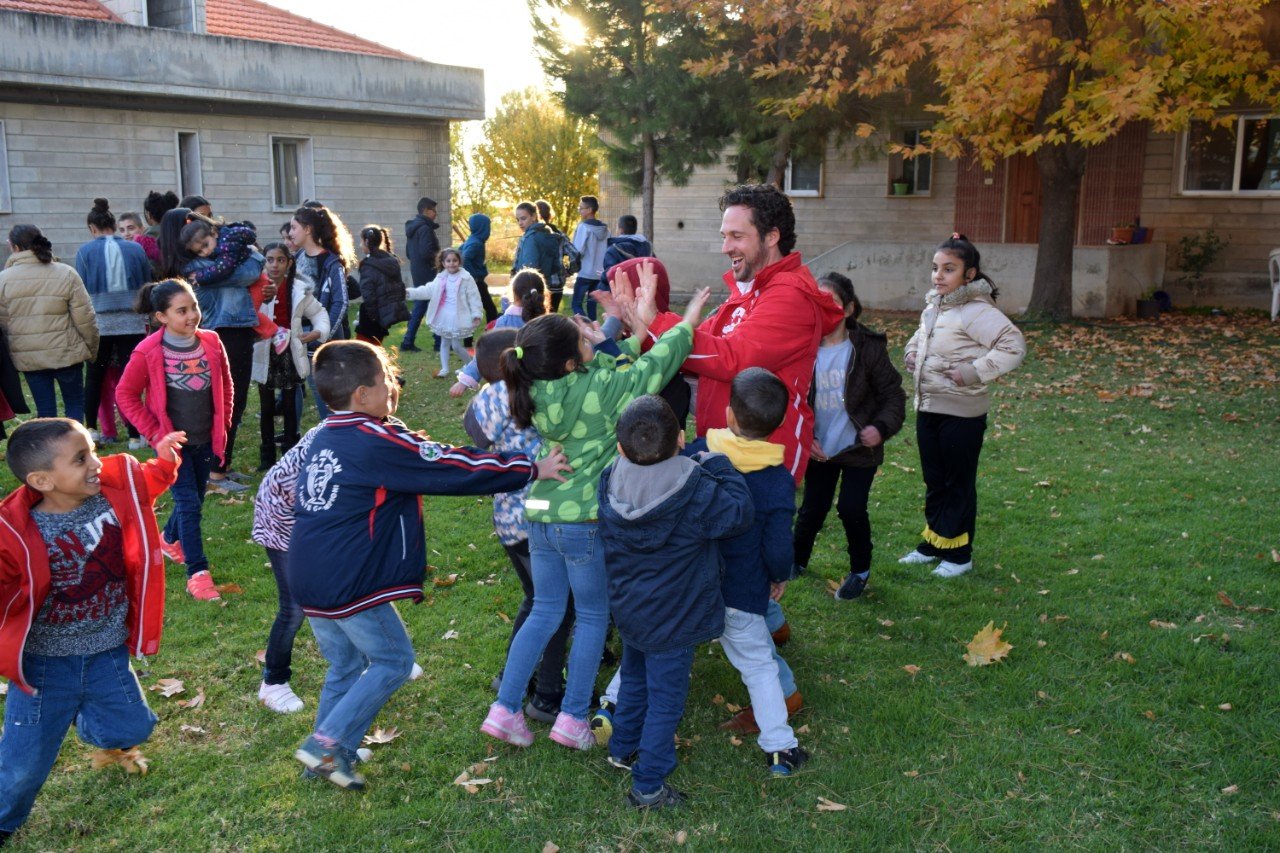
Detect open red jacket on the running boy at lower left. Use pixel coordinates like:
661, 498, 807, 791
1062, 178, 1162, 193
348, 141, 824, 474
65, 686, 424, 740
0, 453, 178, 693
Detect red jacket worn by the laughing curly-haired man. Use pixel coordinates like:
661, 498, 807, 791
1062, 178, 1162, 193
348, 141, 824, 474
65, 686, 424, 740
646, 252, 845, 484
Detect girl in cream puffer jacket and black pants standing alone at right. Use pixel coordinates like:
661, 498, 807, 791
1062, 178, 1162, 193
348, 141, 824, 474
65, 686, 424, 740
899, 234, 1027, 578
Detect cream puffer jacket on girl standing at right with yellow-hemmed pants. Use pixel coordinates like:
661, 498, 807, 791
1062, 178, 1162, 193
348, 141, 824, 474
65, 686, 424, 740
904, 278, 1027, 418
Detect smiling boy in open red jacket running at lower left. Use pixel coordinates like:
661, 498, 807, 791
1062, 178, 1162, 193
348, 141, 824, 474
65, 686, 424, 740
0, 418, 186, 844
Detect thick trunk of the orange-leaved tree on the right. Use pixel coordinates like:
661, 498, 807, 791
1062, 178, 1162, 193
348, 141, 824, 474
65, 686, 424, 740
1027, 142, 1084, 320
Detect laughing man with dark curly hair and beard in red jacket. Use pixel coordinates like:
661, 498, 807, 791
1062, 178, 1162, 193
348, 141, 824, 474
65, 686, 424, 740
634, 184, 844, 484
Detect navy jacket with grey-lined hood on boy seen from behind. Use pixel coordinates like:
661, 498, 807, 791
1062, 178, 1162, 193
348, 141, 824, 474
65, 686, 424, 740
599, 453, 754, 652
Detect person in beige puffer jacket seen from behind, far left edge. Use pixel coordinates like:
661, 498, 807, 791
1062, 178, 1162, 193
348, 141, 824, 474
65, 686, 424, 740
0, 225, 97, 421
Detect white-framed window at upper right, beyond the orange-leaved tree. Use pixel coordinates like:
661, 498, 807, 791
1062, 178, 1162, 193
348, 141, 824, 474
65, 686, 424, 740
1183, 115, 1280, 196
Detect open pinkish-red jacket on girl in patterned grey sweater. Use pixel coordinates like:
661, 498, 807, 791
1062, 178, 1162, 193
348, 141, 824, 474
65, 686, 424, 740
115, 328, 232, 460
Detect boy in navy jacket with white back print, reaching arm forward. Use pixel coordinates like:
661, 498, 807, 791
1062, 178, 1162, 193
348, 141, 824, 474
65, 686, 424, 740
288, 341, 566, 790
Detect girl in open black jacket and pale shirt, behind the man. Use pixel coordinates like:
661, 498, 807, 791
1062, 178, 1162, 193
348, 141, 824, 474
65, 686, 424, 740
795, 273, 906, 601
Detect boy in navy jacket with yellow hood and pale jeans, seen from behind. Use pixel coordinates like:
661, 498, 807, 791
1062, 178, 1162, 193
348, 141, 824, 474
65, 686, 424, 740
690, 368, 809, 776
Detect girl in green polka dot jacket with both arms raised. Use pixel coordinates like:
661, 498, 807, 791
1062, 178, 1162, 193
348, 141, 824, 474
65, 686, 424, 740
480, 264, 710, 749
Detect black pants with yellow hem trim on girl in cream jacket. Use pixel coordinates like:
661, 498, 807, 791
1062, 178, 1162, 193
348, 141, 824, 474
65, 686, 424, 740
915, 411, 987, 562
